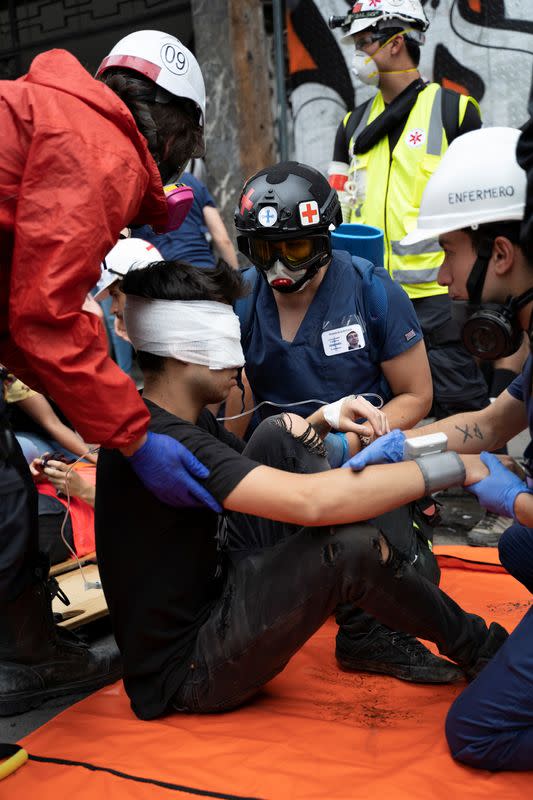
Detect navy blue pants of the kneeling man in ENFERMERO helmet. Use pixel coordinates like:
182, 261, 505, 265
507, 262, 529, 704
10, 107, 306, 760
446, 525, 533, 770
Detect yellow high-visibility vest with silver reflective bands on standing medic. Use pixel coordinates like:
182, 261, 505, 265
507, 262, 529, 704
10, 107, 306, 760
343, 83, 477, 300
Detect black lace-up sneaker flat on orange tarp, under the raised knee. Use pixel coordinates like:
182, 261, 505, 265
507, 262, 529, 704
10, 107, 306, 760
335, 625, 464, 683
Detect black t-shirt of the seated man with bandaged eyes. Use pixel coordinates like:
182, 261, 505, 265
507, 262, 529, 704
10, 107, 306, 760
95, 400, 258, 719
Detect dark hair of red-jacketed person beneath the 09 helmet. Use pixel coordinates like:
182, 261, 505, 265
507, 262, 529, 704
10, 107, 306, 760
100, 67, 203, 171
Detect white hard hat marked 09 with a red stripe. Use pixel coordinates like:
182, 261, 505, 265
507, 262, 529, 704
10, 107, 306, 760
96, 31, 205, 120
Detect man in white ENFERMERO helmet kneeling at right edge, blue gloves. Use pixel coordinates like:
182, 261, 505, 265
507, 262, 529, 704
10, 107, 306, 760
370, 126, 533, 770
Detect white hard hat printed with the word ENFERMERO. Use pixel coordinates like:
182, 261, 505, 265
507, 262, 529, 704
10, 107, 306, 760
401, 128, 527, 245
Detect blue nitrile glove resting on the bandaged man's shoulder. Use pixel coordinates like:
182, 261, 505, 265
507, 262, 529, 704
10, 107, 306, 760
128, 431, 222, 512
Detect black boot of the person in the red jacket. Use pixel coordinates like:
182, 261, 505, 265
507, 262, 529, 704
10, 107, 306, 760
0, 579, 122, 716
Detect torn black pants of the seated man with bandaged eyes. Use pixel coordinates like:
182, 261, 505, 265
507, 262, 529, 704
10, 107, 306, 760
173, 417, 487, 712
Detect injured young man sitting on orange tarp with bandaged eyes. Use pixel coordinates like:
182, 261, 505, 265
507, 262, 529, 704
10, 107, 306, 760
96, 262, 507, 719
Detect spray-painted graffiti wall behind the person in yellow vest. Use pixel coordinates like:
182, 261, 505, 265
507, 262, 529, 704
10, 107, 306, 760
287, 0, 533, 171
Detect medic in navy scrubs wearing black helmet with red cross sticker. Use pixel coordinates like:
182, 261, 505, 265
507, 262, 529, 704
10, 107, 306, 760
235, 162, 432, 466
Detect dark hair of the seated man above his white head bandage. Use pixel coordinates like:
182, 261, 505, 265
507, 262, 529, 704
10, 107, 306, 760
121, 259, 248, 372
